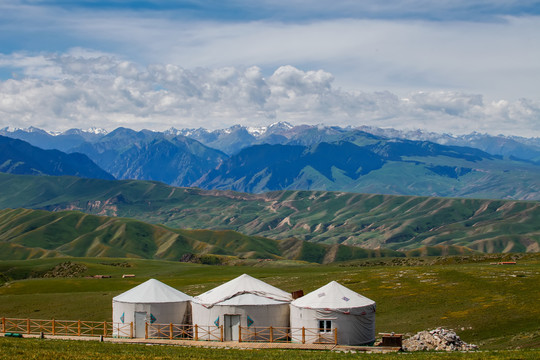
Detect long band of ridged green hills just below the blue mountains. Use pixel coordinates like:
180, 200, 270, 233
0, 174, 540, 256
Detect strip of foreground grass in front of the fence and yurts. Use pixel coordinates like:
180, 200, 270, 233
0, 338, 540, 360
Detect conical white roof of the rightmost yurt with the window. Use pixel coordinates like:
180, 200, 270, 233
291, 281, 375, 309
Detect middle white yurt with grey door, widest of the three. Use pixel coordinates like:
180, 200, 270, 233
192, 274, 292, 341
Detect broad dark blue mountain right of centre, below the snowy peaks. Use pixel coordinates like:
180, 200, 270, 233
193, 138, 540, 200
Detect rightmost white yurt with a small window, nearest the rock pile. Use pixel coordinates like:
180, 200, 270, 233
291, 281, 375, 345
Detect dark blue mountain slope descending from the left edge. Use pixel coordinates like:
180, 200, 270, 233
0, 135, 114, 179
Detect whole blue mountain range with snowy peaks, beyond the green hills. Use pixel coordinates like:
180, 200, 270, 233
0, 123, 540, 200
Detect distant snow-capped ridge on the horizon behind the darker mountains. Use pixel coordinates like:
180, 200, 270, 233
0, 122, 540, 161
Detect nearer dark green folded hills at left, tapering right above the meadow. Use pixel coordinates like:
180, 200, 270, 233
0, 209, 401, 264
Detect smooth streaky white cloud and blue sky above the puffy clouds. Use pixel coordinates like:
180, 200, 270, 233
0, 0, 540, 101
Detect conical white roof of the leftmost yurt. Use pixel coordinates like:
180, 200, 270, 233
113, 279, 192, 303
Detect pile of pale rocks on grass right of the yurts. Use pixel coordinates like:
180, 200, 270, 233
403, 328, 478, 351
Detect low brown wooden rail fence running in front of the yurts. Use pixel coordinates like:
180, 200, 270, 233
0, 318, 337, 344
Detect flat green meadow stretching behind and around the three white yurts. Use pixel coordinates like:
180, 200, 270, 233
0, 254, 540, 350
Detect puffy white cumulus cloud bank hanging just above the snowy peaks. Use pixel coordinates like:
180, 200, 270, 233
0, 49, 540, 137
